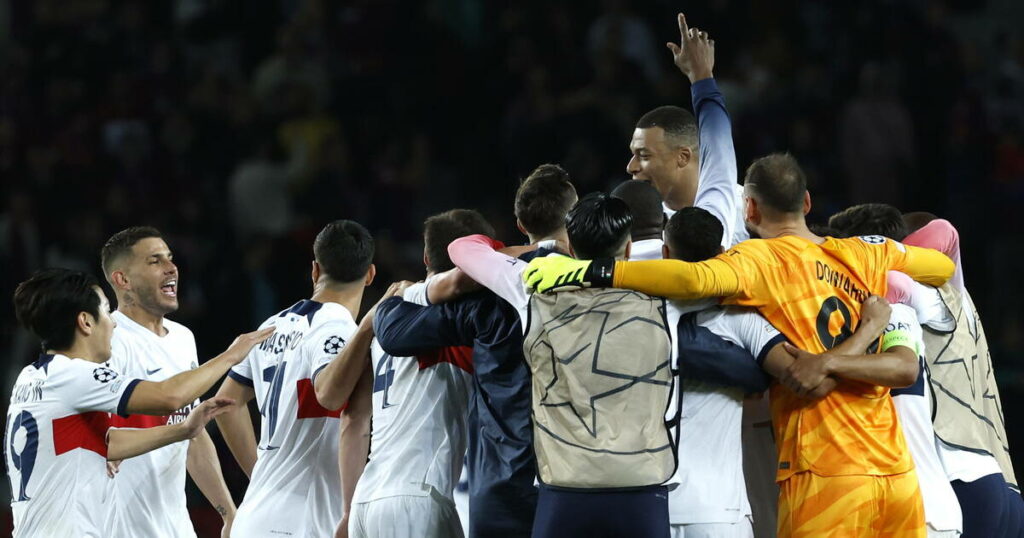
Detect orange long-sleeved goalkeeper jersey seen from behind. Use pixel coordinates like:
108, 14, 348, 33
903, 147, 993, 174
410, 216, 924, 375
614, 236, 953, 481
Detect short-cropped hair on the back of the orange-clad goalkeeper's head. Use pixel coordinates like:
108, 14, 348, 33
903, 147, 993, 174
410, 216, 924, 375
743, 153, 807, 213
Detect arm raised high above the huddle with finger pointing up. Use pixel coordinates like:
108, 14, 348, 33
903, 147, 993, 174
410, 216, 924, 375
668, 13, 738, 248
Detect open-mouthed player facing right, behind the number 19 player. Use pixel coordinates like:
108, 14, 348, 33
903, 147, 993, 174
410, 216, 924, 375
101, 226, 234, 538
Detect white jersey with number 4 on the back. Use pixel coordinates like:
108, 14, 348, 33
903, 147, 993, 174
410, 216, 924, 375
352, 339, 473, 503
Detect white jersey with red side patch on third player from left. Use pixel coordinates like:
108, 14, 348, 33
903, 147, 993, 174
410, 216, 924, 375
228, 300, 356, 538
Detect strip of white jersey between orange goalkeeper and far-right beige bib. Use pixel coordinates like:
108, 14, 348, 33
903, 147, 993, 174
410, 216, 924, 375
886, 304, 963, 532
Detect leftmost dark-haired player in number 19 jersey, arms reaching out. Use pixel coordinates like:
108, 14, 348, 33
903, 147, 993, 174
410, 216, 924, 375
4, 270, 270, 538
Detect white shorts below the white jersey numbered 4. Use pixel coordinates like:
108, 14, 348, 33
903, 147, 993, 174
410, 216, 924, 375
348, 491, 464, 538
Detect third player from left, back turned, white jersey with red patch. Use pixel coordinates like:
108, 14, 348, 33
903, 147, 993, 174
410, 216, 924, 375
217, 220, 376, 538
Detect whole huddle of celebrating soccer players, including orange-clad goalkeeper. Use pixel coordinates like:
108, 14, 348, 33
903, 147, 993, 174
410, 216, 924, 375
4, 10, 1024, 538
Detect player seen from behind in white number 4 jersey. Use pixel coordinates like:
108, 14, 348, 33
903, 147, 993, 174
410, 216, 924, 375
342, 209, 494, 538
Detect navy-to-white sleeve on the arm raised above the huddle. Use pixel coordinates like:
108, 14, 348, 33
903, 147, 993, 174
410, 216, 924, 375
690, 78, 738, 248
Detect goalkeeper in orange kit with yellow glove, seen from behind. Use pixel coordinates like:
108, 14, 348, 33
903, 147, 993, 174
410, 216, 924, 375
523, 154, 954, 538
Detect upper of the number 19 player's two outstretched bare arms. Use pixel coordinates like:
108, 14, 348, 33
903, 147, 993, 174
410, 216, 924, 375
124, 327, 273, 415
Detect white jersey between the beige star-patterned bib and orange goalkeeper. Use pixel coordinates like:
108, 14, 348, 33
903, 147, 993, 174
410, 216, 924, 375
668, 301, 783, 525
